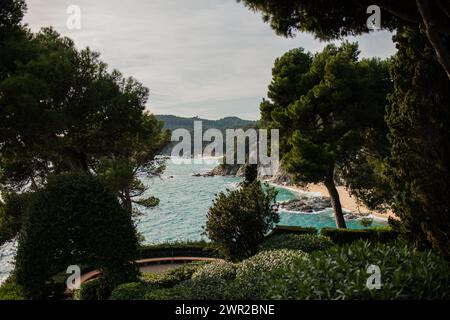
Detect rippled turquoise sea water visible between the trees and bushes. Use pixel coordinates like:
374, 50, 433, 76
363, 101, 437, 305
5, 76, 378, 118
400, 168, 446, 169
137, 160, 384, 243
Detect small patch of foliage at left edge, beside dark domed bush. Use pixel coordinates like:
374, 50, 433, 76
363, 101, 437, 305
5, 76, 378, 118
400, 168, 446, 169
0, 192, 31, 245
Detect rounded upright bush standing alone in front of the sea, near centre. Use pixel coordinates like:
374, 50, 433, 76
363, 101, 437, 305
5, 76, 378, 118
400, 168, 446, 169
205, 182, 279, 260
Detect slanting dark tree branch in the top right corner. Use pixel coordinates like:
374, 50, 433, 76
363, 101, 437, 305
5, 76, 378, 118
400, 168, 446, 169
416, 0, 450, 79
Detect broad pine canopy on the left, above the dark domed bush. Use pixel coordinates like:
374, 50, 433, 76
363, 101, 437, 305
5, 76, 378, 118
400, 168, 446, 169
0, 24, 170, 214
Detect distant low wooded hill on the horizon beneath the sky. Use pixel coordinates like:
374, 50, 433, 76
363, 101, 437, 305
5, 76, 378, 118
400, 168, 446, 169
156, 115, 256, 131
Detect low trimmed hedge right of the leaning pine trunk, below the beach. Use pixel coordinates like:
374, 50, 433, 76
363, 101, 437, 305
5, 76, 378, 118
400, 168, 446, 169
320, 228, 399, 245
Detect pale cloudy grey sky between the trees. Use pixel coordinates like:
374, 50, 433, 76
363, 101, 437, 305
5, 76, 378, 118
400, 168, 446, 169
24, 0, 395, 120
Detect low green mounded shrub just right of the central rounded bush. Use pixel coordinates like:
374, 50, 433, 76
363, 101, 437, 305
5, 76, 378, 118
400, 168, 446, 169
260, 233, 333, 253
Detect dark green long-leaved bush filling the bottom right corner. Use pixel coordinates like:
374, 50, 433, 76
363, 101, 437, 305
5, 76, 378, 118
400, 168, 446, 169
258, 241, 450, 299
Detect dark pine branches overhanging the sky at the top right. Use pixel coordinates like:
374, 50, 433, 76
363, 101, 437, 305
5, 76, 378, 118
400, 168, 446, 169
238, 0, 450, 78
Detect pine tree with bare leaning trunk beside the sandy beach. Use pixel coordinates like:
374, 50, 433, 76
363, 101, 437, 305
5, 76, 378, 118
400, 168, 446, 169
261, 43, 391, 228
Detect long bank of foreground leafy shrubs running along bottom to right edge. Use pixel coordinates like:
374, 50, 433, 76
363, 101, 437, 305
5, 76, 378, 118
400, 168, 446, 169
106, 241, 450, 300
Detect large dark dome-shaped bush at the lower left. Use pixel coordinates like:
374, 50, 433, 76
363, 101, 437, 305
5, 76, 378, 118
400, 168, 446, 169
16, 173, 137, 299
